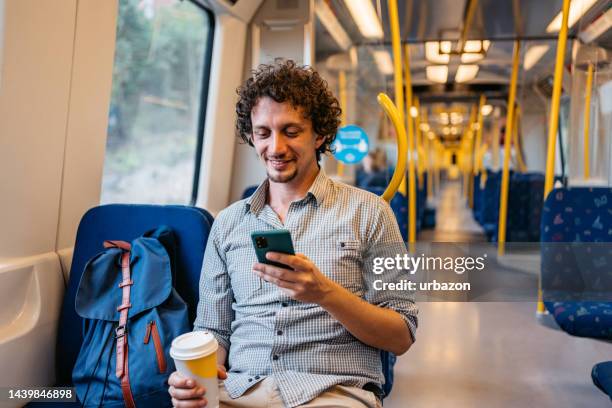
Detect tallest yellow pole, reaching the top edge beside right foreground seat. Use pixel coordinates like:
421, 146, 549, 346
538, 0, 570, 313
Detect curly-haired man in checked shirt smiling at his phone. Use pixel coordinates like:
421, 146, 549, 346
169, 61, 417, 408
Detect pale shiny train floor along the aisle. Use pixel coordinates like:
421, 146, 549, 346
385, 182, 612, 408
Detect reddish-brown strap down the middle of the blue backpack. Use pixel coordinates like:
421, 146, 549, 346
104, 241, 136, 408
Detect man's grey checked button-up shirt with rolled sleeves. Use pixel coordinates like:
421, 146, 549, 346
195, 170, 417, 407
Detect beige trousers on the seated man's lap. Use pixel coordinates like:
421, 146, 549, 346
219, 377, 382, 408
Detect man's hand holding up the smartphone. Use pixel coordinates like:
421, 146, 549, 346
253, 252, 337, 305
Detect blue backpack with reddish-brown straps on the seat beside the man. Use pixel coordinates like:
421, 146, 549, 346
72, 226, 190, 408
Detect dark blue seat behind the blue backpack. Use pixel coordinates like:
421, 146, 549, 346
52, 204, 212, 392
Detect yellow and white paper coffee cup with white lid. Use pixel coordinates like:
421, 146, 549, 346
170, 331, 219, 408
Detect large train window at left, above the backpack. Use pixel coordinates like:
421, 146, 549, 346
101, 0, 214, 204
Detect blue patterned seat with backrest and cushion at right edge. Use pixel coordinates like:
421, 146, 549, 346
541, 187, 612, 340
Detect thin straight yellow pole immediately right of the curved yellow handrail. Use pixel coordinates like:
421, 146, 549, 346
404, 44, 416, 245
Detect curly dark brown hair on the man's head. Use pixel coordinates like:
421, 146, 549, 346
236, 60, 342, 161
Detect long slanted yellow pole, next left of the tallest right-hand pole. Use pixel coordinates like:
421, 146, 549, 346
497, 41, 521, 255
